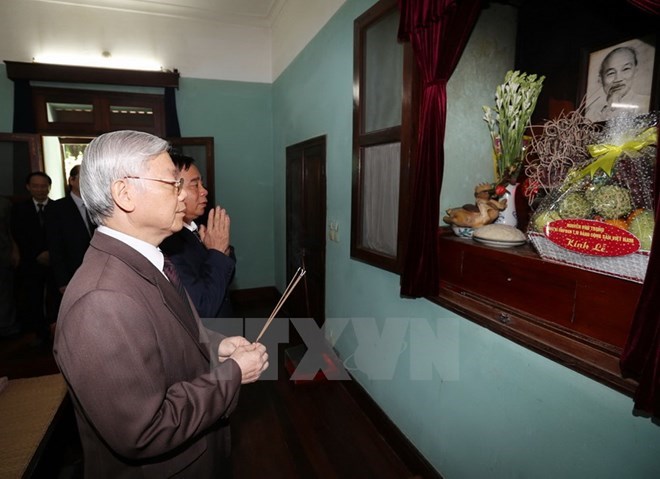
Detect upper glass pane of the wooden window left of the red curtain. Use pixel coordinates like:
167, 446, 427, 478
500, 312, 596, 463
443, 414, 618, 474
362, 10, 403, 133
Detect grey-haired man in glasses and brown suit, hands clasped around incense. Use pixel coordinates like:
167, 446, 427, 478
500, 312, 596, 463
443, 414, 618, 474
53, 131, 268, 479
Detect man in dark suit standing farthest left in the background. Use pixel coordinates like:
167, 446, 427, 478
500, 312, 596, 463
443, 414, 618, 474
11, 171, 57, 341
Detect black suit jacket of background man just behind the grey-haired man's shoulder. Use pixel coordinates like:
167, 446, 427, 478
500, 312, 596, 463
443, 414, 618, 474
46, 195, 90, 288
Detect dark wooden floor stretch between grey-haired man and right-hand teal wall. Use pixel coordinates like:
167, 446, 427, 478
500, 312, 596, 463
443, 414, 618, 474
231, 346, 439, 479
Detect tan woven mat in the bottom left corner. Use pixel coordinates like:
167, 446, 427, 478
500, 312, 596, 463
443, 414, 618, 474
0, 374, 66, 479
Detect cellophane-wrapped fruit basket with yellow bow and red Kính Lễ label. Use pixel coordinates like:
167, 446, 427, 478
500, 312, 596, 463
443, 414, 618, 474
527, 115, 657, 283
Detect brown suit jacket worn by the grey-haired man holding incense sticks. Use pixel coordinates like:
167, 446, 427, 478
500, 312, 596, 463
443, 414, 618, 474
53, 231, 241, 479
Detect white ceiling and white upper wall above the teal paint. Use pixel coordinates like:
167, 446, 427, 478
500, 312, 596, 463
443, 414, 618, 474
0, 0, 346, 83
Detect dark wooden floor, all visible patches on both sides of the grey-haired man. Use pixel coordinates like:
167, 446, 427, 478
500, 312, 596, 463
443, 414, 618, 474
0, 298, 440, 479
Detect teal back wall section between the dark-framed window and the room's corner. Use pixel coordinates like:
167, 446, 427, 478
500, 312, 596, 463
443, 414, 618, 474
176, 78, 275, 289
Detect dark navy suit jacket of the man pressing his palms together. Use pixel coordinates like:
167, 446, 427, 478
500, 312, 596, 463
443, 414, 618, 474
160, 228, 236, 318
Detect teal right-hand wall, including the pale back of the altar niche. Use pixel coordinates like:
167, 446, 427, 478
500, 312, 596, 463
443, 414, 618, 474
273, 0, 660, 479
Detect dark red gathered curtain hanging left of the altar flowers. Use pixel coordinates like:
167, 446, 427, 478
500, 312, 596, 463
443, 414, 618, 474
398, 0, 481, 297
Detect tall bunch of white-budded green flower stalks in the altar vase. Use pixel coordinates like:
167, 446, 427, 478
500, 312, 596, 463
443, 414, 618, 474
483, 70, 545, 183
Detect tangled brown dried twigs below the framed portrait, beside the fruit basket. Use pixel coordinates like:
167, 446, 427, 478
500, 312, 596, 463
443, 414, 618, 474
525, 103, 603, 205
